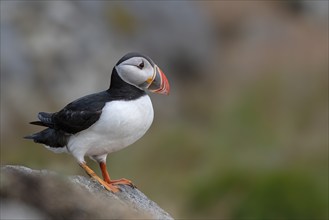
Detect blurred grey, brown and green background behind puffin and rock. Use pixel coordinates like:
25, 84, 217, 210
0, 1, 328, 219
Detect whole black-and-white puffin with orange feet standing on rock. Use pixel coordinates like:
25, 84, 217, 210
24, 52, 170, 193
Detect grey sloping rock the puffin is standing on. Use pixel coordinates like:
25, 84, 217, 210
0, 165, 173, 219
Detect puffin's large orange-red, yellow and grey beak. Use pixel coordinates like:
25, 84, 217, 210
146, 65, 170, 95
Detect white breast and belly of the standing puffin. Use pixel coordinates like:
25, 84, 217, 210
67, 95, 153, 162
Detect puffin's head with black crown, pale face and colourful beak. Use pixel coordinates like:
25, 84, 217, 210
115, 53, 170, 95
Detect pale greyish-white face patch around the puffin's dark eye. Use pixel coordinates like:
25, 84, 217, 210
115, 57, 154, 87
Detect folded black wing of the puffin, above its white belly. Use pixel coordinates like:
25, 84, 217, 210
31, 91, 112, 134
